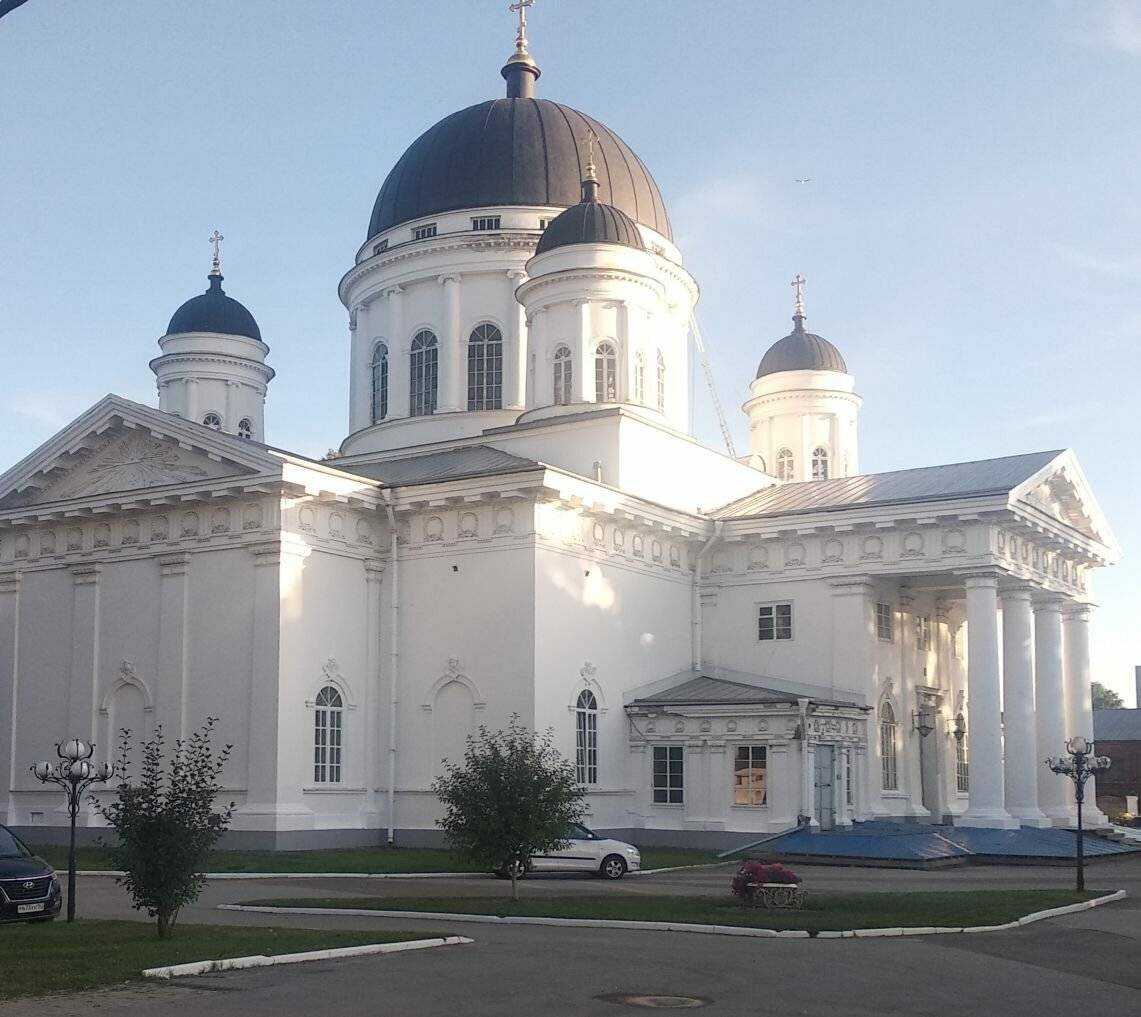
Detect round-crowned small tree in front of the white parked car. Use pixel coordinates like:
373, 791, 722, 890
432, 713, 586, 901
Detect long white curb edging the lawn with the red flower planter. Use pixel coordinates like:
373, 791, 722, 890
218, 890, 1128, 939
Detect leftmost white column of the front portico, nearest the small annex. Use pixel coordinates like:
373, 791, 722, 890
955, 572, 1018, 830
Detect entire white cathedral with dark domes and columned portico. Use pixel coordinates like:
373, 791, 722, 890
0, 25, 1119, 848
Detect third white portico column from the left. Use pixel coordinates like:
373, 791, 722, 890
1034, 597, 1076, 824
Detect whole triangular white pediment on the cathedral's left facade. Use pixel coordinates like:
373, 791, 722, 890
0, 396, 280, 511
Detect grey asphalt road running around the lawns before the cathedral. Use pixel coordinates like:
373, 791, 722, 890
8, 858, 1141, 1017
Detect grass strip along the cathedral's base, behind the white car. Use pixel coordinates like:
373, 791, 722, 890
30, 845, 715, 872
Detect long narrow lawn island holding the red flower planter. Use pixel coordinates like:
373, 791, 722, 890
244, 890, 1097, 933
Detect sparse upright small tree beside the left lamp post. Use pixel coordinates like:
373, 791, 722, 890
97, 717, 234, 938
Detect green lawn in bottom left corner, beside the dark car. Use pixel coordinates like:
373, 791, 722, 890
0, 919, 427, 1000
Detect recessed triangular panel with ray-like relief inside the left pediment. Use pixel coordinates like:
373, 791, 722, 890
0, 428, 253, 508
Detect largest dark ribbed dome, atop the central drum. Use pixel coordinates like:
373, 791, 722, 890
369, 98, 673, 240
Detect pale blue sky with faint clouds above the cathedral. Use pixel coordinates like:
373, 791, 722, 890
0, 0, 1141, 705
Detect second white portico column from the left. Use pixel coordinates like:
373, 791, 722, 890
1002, 586, 1050, 826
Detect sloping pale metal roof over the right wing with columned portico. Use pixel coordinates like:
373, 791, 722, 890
713, 450, 1061, 519
